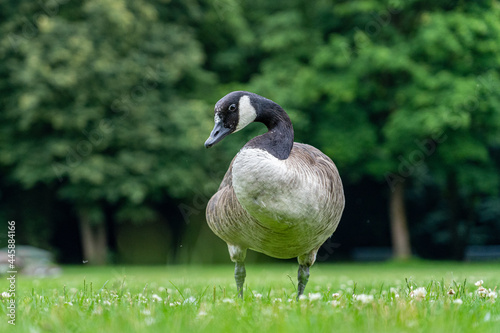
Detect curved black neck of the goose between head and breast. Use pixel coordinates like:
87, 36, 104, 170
245, 101, 293, 160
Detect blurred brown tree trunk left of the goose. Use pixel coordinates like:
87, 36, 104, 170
80, 210, 108, 265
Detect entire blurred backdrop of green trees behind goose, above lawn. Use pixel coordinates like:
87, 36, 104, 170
0, 0, 500, 265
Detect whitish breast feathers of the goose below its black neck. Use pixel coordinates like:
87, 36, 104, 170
232, 148, 314, 229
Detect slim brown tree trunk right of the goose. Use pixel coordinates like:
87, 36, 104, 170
389, 182, 411, 259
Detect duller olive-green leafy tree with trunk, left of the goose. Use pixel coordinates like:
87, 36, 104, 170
0, 1, 219, 264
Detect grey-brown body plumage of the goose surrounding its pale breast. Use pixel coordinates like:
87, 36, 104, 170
206, 143, 344, 258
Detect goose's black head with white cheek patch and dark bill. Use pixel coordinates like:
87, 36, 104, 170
205, 91, 258, 148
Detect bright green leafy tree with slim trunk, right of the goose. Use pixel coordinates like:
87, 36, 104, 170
243, 1, 500, 258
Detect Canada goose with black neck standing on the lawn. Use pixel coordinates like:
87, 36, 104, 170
205, 91, 344, 298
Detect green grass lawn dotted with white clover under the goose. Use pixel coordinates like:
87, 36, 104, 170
0, 262, 500, 333
